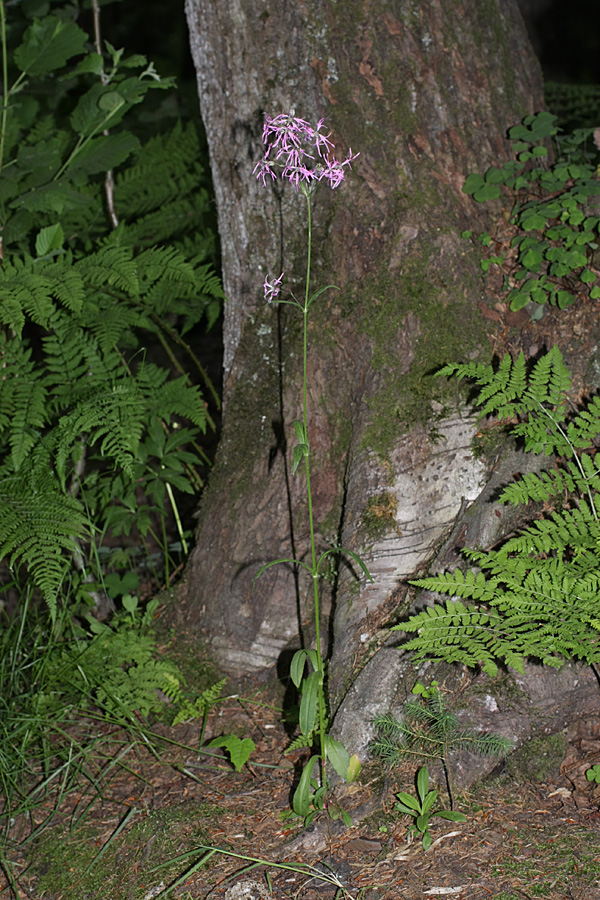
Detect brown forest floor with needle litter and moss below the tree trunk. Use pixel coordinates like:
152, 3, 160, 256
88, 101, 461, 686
0, 687, 600, 900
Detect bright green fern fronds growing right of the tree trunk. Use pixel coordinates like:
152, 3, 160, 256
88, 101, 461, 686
396, 348, 600, 675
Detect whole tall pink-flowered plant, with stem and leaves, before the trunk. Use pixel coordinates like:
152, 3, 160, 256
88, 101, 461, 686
254, 110, 372, 824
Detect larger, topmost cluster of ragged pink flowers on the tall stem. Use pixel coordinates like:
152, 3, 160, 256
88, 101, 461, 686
254, 110, 359, 190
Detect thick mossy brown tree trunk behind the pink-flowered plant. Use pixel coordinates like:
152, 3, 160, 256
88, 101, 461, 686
181, 0, 542, 740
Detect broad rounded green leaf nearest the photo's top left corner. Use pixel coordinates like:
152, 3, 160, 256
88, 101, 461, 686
14, 16, 87, 77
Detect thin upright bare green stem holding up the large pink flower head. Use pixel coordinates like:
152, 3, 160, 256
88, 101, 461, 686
302, 192, 326, 785
